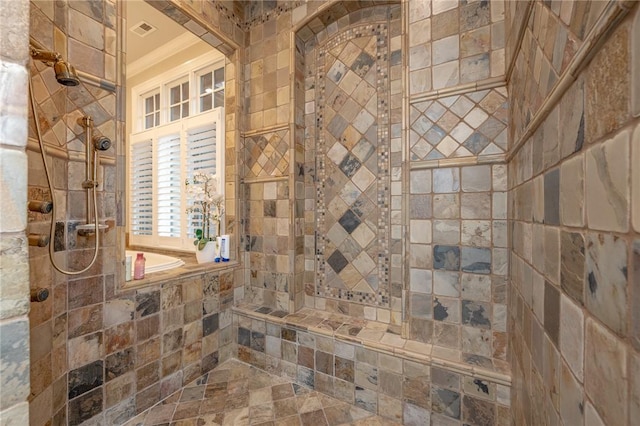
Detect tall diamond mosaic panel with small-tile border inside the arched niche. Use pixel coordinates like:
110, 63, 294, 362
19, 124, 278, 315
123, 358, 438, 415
316, 24, 390, 306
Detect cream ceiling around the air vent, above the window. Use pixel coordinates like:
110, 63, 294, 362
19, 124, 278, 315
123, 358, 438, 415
125, 0, 197, 65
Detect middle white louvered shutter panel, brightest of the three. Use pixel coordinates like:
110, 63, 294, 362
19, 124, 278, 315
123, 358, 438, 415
156, 134, 184, 238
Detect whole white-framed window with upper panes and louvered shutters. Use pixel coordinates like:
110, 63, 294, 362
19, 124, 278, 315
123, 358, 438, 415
128, 58, 224, 251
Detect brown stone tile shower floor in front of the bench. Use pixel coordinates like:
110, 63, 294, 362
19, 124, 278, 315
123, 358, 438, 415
126, 359, 398, 426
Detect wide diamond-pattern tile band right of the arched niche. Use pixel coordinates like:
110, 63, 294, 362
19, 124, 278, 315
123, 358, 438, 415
409, 88, 508, 161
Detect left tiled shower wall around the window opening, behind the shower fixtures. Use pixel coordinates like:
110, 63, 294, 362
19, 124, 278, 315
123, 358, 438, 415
25, 1, 243, 425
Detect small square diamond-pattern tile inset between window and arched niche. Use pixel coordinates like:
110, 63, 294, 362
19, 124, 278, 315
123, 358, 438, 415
245, 130, 289, 178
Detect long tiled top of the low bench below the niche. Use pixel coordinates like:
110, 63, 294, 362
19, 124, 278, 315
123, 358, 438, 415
233, 305, 511, 386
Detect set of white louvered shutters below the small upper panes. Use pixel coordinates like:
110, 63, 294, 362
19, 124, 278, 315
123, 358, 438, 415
129, 108, 224, 251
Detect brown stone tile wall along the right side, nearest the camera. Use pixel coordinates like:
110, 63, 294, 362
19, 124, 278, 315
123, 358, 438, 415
508, 2, 640, 425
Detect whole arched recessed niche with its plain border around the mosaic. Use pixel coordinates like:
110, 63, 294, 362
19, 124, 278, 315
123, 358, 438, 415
301, 6, 402, 329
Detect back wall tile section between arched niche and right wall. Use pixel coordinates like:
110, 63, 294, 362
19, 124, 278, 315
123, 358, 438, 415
405, 1, 509, 356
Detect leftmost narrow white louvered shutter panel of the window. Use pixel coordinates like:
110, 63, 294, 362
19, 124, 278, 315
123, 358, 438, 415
129, 139, 153, 235
